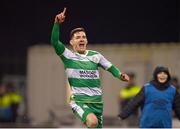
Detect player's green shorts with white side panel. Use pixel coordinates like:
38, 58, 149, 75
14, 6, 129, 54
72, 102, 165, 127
70, 101, 103, 128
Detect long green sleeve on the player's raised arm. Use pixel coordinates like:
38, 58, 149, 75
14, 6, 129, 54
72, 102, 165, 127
51, 23, 65, 55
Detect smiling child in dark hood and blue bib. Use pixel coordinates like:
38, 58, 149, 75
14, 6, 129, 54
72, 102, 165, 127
118, 66, 180, 128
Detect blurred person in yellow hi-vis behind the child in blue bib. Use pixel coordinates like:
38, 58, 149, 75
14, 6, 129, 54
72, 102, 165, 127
119, 72, 140, 127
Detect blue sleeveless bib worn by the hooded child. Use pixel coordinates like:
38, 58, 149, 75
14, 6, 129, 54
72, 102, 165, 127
140, 83, 176, 128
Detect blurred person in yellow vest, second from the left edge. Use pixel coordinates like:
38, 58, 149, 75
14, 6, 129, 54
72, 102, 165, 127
6, 82, 22, 122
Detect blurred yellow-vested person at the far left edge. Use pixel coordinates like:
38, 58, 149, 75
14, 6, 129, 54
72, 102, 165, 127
0, 84, 12, 123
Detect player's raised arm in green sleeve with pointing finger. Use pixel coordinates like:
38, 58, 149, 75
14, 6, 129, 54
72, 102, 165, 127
51, 8, 66, 55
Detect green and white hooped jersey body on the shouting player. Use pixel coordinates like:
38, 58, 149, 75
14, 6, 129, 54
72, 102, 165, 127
60, 48, 112, 103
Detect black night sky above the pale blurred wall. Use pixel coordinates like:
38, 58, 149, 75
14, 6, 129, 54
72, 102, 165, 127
0, 0, 180, 74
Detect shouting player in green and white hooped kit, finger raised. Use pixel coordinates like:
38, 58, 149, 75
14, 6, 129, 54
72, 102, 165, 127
51, 8, 129, 128
